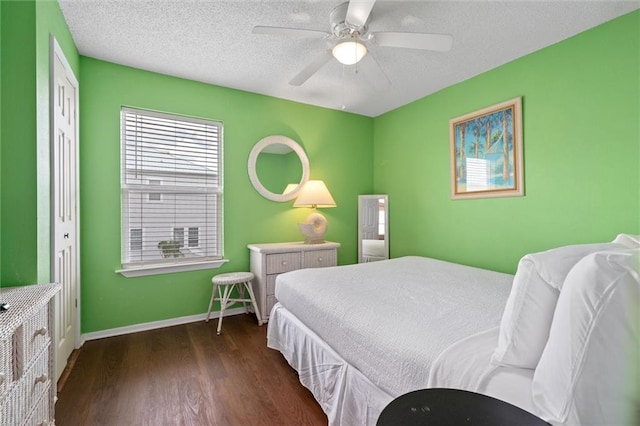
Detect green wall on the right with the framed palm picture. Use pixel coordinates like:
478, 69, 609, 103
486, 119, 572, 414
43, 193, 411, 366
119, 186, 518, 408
374, 11, 640, 273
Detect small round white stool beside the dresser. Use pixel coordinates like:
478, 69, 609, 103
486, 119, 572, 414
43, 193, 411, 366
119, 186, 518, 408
206, 272, 263, 335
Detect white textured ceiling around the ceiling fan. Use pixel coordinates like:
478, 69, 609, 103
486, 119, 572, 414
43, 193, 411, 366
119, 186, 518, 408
59, 0, 640, 117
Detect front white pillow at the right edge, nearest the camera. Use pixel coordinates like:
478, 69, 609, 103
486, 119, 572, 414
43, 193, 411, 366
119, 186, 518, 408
531, 249, 640, 426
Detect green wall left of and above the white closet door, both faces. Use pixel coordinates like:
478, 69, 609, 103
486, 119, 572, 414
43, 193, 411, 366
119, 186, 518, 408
0, 0, 78, 286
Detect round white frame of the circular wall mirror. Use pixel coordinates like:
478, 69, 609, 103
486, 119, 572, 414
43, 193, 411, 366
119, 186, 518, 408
248, 135, 310, 202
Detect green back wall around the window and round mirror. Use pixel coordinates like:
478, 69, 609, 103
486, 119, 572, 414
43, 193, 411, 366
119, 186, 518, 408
80, 57, 373, 333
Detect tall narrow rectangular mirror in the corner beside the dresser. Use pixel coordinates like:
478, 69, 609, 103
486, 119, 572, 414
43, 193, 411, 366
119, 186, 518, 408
358, 195, 389, 263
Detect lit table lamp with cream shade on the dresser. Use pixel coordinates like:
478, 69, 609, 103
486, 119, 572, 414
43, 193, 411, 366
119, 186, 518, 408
293, 180, 336, 244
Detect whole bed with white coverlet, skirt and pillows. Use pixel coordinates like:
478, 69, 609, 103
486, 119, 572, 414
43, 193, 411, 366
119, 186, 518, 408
267, 236, 640, 425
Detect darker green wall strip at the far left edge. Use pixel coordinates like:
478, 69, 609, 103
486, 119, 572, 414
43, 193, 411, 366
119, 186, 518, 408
0, 1, 38, 286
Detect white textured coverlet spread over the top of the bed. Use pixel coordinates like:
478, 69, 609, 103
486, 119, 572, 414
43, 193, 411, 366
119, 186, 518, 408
276, 256, 513, 396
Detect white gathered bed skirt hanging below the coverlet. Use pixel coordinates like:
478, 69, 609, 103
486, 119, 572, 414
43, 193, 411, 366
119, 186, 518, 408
267, 303, 394, 426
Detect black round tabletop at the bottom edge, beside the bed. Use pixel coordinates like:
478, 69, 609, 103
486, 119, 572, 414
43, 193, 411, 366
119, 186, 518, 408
377, 388, 549, 426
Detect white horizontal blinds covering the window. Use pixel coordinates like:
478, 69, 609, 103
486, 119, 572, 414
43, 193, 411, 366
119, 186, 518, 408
121, 108, 222, 268
